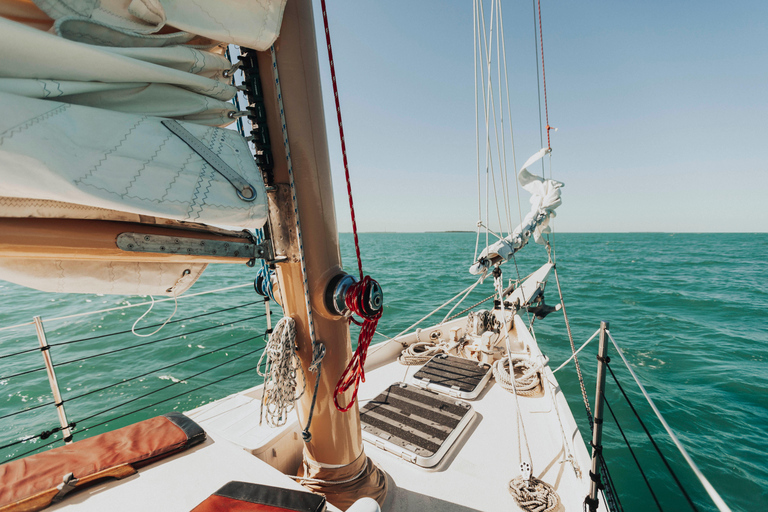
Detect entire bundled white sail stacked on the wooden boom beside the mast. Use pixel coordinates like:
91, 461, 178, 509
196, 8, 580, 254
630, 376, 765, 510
0, 0, 286, 293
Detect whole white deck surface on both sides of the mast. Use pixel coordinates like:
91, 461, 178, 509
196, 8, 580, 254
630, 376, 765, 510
42, 350, 605, 512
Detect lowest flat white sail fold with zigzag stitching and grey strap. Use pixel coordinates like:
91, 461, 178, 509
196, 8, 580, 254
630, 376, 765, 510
0, 93, 267, 229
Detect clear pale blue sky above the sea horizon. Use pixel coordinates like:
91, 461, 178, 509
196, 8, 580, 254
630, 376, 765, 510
308, 0, 768, 232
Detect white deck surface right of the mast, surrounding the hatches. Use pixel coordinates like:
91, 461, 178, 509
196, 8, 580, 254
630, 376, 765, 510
359, 363, 605, 512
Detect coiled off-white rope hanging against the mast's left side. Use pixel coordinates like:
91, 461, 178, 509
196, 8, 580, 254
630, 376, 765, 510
256, 317, 306, 427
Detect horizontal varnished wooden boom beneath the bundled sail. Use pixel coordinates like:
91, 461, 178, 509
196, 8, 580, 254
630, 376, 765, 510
0, 218, 255, 263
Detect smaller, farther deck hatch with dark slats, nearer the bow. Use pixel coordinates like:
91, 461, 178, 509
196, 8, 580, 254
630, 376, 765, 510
411, 354, 491, 400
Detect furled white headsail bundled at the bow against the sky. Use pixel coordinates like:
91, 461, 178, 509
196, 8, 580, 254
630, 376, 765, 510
469, 148, 563, 275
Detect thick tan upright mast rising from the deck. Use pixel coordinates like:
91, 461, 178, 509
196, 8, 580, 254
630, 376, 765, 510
258, 0, 386, 500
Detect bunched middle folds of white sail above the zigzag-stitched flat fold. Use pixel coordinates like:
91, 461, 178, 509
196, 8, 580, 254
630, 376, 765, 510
0, 18, 236, 126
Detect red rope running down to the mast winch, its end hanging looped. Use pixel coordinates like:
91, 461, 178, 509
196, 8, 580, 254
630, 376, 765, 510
320, 0, 383, 412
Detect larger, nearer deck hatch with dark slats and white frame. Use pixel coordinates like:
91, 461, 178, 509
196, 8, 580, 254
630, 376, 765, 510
360, 383, 474, 467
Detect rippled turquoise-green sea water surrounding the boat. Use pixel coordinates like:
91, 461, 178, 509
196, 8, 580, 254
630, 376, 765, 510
0, 233, 768, 511
